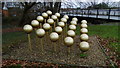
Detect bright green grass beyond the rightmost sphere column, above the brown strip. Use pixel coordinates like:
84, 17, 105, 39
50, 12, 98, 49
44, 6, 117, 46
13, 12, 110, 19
76, 25, 119, 39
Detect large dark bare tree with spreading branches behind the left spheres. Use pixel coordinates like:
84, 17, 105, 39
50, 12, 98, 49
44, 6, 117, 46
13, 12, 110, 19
19, 2, 61, 26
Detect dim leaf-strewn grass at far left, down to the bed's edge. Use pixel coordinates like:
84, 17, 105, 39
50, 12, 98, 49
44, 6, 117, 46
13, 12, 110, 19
2, 32, 27, 53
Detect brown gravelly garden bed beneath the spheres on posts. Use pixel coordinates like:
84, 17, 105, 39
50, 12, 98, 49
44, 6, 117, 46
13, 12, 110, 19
3, 36, 111, 66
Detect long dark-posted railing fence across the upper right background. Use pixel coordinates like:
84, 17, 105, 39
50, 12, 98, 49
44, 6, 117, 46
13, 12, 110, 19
60, 8, 120, 20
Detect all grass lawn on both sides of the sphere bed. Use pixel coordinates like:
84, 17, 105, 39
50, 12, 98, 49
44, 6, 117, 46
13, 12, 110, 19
2, 25, 120, 52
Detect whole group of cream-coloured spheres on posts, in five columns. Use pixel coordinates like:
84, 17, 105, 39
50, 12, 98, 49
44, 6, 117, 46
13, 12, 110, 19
23, 10, 90, 51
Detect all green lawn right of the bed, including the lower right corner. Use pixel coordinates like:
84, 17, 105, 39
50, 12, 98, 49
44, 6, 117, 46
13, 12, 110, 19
76, 25, 120, 54
